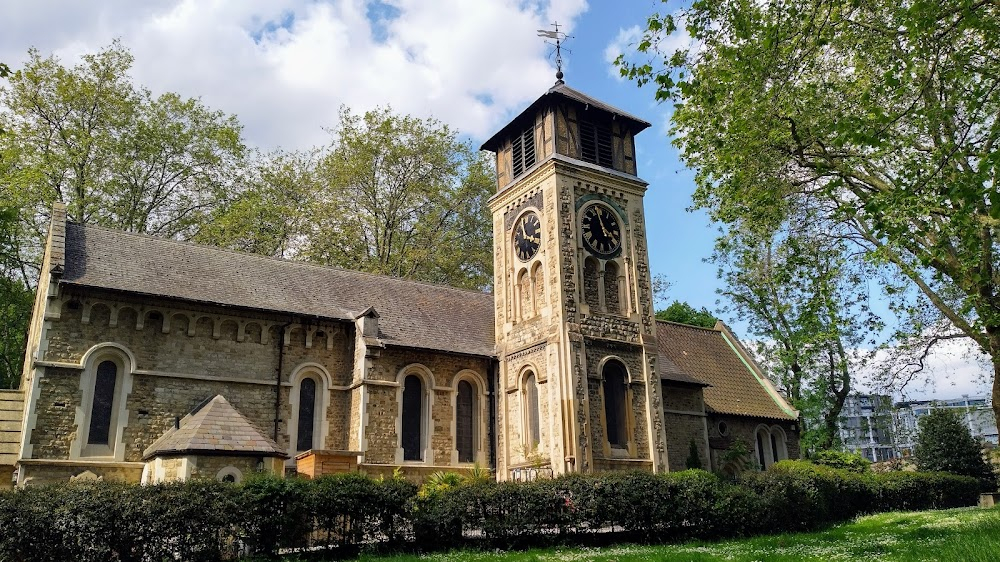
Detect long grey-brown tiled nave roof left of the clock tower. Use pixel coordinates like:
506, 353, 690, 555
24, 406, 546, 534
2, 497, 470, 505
61, 223, 494, 357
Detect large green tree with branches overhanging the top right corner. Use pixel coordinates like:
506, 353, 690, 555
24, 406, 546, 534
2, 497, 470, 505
619, 0, 1000, 415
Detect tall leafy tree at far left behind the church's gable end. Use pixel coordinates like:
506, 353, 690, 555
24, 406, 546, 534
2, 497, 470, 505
0, 41, 245, 274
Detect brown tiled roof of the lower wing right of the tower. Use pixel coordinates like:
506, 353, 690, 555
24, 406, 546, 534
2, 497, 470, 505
656, 320, 797, 420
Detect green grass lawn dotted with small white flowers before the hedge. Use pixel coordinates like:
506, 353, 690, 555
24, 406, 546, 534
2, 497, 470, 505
346, 508, 1000, 562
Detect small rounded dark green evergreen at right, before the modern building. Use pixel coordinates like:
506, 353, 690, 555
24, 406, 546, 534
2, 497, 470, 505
913, 408, 996, 489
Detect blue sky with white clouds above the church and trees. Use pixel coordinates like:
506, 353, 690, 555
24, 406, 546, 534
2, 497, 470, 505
0, 0, 984, 397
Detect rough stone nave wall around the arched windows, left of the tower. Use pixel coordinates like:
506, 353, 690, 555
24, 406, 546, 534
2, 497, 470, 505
22, 288, 490, 481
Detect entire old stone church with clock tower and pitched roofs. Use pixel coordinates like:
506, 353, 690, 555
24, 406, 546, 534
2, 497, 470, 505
0, 80, 799, 485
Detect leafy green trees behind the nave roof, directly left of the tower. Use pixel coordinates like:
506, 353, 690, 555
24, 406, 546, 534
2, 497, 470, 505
203, 108, 496, 289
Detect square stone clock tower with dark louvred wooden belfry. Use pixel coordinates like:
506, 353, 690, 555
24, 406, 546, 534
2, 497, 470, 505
483, 76, 667, 479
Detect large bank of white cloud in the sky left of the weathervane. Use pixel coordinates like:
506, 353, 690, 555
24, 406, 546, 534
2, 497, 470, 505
0, 0, 587, 148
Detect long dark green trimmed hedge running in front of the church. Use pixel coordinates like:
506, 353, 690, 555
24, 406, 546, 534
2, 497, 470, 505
0, 461, 979, 561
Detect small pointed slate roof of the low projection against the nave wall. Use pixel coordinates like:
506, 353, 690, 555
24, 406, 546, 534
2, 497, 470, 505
142, 394, 288, 460
